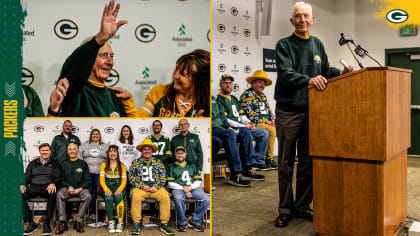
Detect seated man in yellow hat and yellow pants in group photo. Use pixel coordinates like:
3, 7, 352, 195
128, 138, 175, 235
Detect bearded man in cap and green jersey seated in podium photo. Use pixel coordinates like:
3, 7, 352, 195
217, 74, 269, 170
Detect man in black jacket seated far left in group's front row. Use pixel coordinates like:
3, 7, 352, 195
21, 143, 61, 235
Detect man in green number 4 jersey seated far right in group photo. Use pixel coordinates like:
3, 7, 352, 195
168, 146, 210, 232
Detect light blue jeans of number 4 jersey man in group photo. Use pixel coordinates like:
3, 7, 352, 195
172, 188, 210, 225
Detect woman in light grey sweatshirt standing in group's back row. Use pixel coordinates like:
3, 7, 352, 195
78, 129, 108, 219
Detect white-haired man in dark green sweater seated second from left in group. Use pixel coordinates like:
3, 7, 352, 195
55, 143, 92, 234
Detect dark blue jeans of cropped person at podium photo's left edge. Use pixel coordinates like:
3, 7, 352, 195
212, 129, 242, 173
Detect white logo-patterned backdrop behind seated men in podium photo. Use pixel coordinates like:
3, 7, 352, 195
212, 0, 259, 98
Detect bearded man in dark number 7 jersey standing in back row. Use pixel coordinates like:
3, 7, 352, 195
147, 120, 172, 167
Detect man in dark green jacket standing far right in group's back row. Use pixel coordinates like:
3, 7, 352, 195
171, 119, 203, 175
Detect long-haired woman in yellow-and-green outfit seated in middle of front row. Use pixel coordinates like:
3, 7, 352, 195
99, 145, 127, 233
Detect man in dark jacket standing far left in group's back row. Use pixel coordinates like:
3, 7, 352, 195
51, 120, 80, 165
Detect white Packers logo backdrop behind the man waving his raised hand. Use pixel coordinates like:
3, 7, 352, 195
22, 0, 210, 113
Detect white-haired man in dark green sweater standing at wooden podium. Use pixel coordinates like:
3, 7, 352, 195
274, 2, 354, 227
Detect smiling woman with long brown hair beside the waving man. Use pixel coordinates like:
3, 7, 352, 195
137, 49, 210, 117
